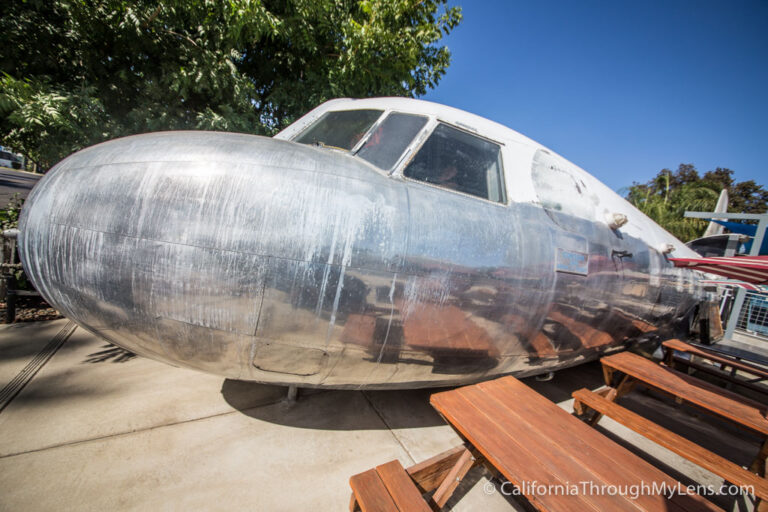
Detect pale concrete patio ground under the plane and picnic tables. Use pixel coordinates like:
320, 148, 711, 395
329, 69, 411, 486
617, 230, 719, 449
0, 320, 759, 511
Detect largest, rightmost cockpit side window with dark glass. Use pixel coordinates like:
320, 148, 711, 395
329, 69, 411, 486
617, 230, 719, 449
403, 124, 506, 203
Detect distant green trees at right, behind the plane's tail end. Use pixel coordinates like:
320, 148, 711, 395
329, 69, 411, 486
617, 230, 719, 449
626, 164, 768, 241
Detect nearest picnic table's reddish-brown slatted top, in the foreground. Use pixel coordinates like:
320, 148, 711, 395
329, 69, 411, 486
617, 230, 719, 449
430, 377, 719, 512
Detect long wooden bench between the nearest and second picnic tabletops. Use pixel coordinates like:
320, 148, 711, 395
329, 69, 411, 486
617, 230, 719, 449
573, 389, 768, 500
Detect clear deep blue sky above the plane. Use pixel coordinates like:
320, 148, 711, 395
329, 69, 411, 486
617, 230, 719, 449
423, 0, 768, 190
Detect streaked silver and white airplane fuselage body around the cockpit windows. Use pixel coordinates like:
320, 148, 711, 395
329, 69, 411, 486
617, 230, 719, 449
19, 98, 703, 388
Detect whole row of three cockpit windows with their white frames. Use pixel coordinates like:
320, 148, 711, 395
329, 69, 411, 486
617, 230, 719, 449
294, 109, 506, 203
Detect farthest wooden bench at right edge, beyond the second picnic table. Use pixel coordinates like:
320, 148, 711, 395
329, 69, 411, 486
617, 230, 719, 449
661, 339, 768, 394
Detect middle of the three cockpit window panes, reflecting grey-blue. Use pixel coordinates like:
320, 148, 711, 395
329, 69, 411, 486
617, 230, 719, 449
357, 112, 427, 171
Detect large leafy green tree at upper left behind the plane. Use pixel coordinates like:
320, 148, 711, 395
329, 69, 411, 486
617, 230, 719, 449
0, 0, 461, 166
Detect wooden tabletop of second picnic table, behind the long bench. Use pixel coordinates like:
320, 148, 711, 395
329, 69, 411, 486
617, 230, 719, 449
600, 352, 768, 435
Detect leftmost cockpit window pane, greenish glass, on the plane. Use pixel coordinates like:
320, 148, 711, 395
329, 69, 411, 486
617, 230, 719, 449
296, 110, 383, 151
